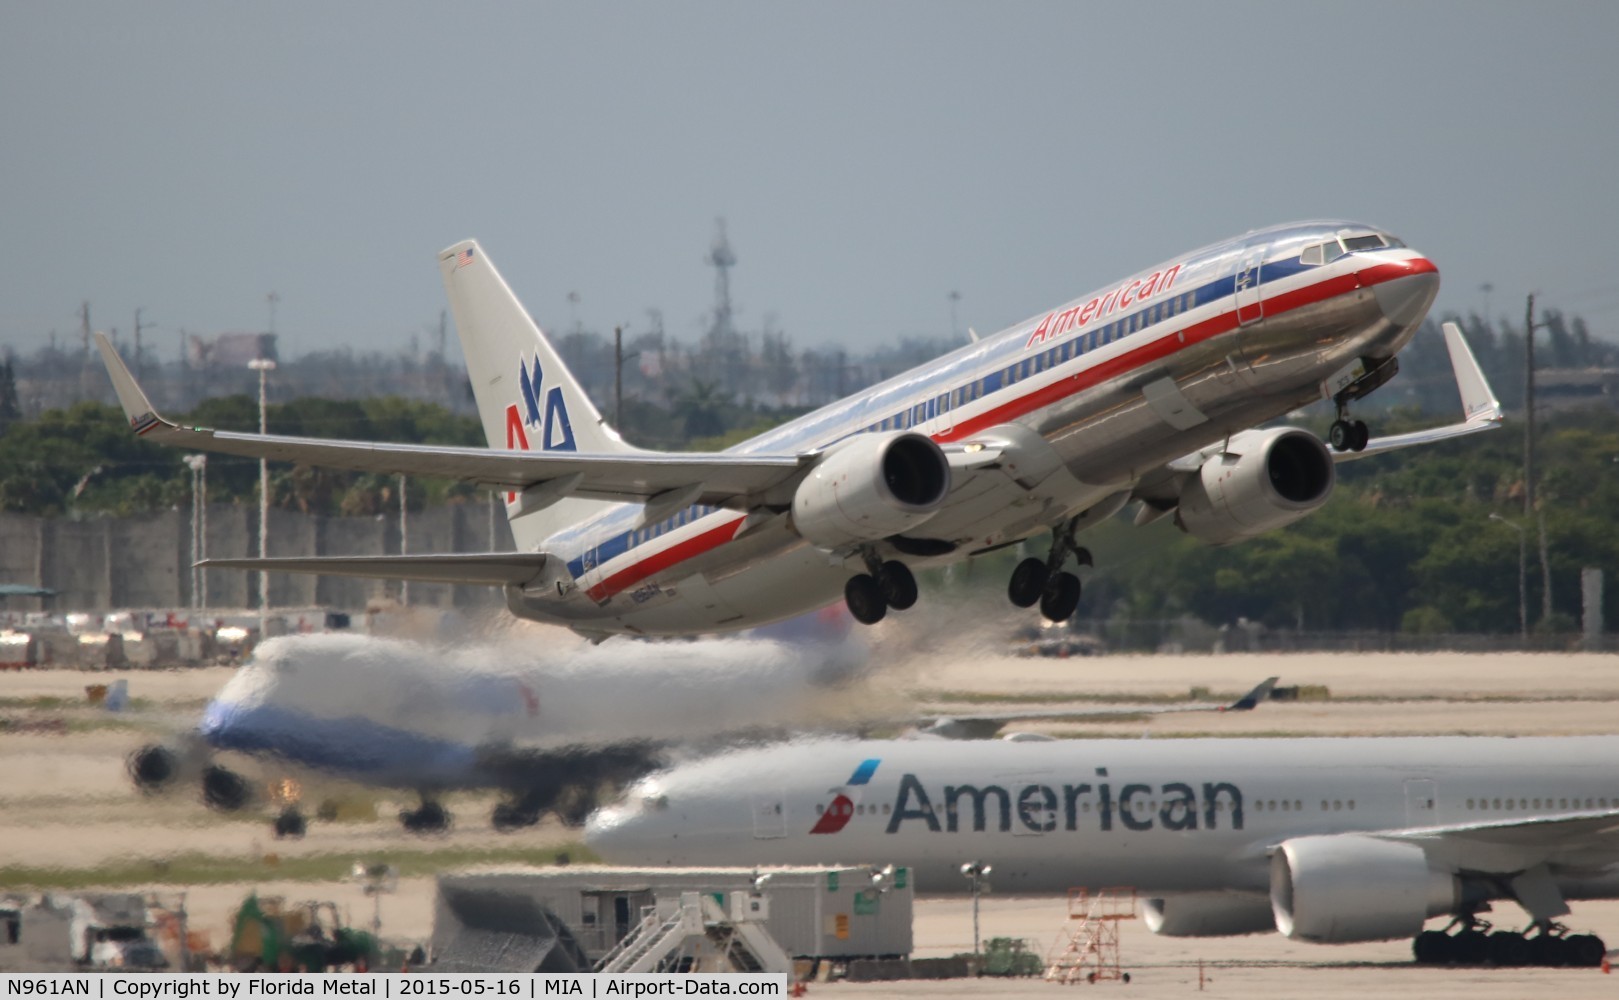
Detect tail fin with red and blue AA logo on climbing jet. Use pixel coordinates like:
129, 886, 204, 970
439, 239, 640, 550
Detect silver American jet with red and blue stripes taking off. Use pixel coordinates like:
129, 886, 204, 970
99, 222, 1501, 638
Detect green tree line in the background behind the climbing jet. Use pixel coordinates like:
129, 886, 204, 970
0, 305, 1619, 633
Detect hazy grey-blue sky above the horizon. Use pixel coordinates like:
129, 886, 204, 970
0, 0, 1619, 356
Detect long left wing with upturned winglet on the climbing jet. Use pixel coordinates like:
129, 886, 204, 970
96, 333, 814, 504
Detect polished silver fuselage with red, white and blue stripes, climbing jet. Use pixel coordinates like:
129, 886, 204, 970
507, 222, 1438, 634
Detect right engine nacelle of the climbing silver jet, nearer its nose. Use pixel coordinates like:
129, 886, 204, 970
1175, 427, 1337, 545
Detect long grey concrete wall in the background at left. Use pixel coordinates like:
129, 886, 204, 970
0, 502, 512, 612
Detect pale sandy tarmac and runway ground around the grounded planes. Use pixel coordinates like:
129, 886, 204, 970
0, 646, 1619, 1000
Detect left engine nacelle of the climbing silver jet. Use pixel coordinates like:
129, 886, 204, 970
793, 432, 950, 549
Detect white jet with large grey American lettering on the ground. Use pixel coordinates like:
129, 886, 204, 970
586, 736, 1619, 964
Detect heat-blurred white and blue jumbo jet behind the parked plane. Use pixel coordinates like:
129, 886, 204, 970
128, 608, 866, 835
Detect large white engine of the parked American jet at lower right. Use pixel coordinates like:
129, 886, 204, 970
1271, 833, 1460, 945
